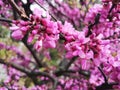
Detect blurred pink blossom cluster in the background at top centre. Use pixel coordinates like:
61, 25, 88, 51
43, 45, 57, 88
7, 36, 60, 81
50, 0, 81, 27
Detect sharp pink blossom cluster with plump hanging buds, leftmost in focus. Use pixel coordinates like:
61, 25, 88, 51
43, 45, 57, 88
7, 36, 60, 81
10, 10, 59, 51
